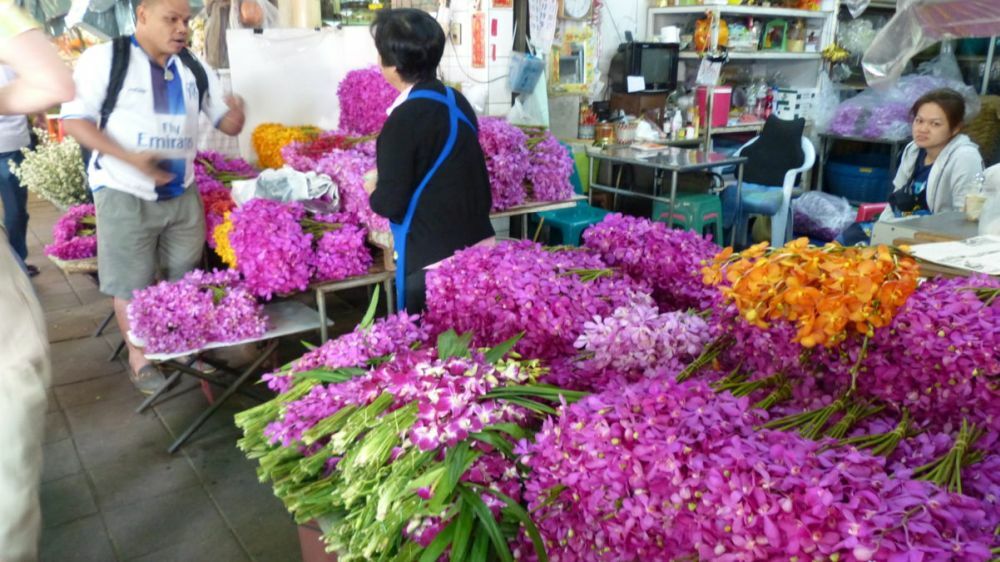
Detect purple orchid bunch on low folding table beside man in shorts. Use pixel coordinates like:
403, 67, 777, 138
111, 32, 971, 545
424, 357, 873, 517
128, 270, 267, 353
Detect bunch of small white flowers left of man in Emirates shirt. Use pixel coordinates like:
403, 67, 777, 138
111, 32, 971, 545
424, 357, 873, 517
11, 129, 90, 209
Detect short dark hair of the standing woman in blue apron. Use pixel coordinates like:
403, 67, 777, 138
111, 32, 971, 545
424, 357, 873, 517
371, 8, 445, 82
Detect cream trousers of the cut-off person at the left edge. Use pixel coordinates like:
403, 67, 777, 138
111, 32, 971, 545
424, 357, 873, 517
0, 228, 49, 562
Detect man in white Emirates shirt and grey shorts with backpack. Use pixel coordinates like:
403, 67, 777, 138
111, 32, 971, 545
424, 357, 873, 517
62, 0, 245, 394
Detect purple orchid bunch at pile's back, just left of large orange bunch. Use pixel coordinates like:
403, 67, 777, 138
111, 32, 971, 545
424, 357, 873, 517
583, 213, 719, 310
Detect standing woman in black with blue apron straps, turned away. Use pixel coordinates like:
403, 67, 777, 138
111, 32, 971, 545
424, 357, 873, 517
370, 9, 494, 313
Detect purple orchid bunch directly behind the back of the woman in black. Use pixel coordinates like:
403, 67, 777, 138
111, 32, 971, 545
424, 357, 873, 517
479, 117, 532, 211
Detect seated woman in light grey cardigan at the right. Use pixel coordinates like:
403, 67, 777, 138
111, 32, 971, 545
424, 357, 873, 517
879, 88, 983, 220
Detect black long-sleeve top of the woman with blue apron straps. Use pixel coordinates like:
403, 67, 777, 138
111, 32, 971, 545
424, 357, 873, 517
370, 80, 494, 274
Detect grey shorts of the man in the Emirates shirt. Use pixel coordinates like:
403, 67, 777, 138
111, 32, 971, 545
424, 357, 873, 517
94, 186, 205, 300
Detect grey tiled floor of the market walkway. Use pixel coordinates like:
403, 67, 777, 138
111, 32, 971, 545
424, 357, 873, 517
28, 195, 344, 562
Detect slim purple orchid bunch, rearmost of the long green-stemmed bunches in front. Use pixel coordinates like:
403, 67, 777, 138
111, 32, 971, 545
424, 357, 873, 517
263, 312, 428, 393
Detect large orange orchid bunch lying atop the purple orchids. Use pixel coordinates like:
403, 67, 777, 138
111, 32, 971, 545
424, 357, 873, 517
702, 238, 919, 348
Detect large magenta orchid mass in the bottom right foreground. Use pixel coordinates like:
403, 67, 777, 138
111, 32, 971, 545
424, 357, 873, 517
518, 379, 993, 562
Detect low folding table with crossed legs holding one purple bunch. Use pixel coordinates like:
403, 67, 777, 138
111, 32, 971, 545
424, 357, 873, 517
129, 301, 321, 453
